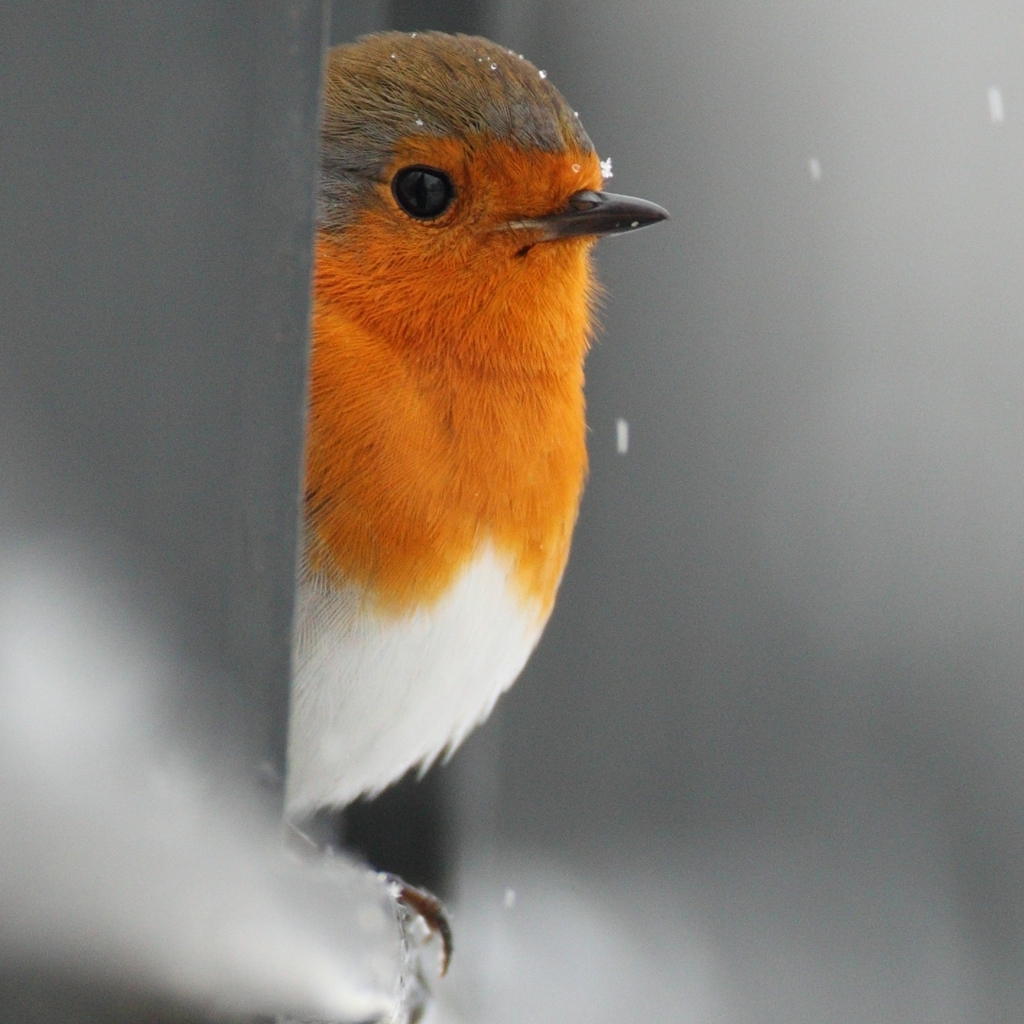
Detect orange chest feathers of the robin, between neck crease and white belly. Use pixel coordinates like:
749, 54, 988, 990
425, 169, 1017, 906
305, 292, 587, 612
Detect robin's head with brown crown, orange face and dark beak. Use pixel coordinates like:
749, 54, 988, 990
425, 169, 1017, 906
317, 33, 667, 372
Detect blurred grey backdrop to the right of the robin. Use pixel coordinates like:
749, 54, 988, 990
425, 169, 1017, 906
335, 0, 1024, 1021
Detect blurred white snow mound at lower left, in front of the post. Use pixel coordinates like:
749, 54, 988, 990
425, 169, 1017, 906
0, 548, 407, 1021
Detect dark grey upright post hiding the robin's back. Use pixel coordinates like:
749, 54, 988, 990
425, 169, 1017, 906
0, 0, 327, 1021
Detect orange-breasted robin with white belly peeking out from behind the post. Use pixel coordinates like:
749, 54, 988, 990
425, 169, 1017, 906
286, 32, 668, 822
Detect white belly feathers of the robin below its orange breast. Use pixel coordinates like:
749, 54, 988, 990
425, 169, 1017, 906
287, 545, 546, 818
